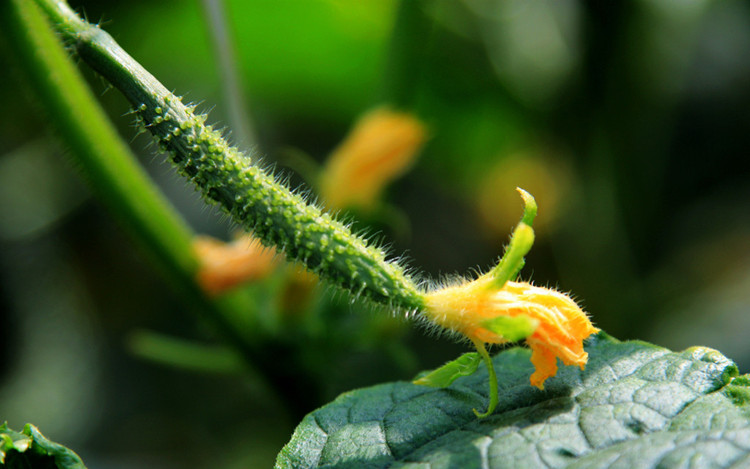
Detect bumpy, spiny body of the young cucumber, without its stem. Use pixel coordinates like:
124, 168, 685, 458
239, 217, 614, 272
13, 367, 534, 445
136, 95, 424, 310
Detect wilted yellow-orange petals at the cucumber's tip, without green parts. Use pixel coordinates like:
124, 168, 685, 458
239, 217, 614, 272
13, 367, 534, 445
426, 274, 598, 389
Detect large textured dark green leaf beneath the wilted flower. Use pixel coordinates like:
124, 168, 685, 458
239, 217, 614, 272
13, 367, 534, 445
277, 333, 750, 468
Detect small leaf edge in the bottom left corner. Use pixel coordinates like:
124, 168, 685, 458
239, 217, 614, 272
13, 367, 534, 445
0, 423, 86, 469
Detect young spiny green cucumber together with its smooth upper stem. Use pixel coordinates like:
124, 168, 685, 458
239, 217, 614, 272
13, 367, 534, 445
37, 0, 424, 311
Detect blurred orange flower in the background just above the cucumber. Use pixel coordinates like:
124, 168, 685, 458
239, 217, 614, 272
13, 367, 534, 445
320, 108, 426, 210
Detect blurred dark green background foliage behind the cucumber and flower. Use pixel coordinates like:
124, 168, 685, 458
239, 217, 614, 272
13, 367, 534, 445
0, 0, 750, 468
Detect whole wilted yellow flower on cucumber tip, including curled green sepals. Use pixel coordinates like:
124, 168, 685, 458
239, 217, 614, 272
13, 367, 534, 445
414, 189, 598, 418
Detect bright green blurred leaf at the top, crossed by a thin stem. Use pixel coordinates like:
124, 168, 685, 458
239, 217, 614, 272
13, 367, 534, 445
114, 0, 394, 120
